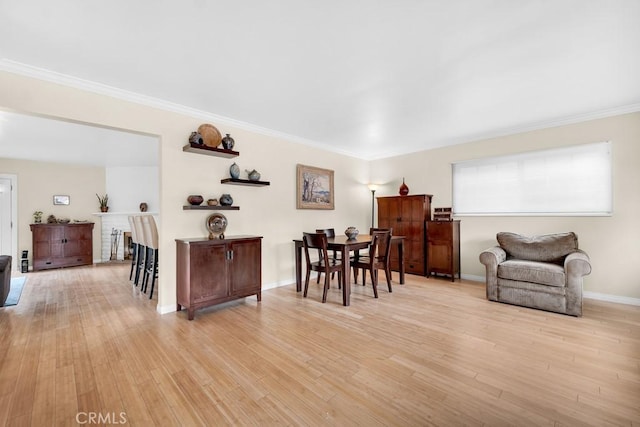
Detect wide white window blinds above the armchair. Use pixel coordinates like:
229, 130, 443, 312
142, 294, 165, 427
452, 142, 612, 215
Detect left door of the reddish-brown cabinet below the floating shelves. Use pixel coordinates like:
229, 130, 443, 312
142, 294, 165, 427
190, 245, 229, 304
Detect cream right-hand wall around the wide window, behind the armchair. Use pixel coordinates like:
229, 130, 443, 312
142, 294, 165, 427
371, 113, 640, 298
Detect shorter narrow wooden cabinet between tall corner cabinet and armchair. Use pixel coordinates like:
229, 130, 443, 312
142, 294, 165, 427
427, 220, 460, 282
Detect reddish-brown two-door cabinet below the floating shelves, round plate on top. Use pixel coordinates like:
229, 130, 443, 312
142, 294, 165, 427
176, 236, 262, 320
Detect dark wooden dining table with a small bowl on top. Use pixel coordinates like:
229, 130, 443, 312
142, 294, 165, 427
293, 234, 404, 306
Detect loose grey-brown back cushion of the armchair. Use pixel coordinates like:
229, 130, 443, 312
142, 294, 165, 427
496, 232, 578, 263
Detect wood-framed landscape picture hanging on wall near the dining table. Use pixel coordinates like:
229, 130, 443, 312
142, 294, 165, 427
296, 165, 334, 209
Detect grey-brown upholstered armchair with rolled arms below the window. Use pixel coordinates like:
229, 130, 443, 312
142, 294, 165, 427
480, 232, 591, 316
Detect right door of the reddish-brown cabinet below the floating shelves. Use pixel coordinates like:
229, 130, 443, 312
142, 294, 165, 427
227, 239, 262, 296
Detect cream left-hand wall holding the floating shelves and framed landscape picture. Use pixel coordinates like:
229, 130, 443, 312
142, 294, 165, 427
0, 71, 371, 312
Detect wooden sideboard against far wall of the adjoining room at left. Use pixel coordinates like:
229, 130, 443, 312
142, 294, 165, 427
30, 222, 93, 271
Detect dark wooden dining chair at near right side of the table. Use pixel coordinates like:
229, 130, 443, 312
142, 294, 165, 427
350, 230, 393, 298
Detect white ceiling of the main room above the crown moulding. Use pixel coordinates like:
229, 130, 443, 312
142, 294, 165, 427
0, 0, 640, 164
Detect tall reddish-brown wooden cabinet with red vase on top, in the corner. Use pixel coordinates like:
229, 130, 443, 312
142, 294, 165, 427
377, 194, 433, 276
